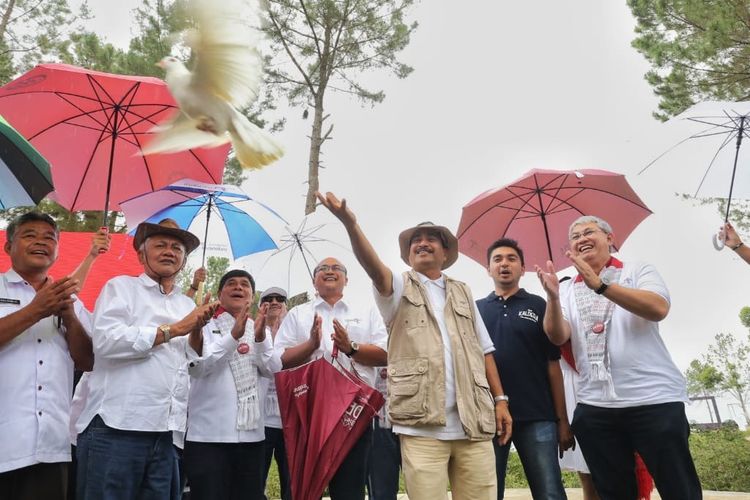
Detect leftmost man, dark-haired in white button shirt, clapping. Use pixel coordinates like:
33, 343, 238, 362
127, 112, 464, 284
0, 212, 94, 500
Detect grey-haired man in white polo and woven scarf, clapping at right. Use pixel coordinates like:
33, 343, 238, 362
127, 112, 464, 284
537, 216, 702, 500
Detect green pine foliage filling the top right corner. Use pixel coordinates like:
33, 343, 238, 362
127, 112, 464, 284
628, 0, 750, 120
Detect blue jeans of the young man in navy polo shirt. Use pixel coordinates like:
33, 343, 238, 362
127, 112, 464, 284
492, 421, 567, 500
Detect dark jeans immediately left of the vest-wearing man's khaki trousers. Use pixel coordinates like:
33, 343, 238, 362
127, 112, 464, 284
367, 417, 401, 500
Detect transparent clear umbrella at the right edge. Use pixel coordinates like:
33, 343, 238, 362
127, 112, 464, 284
640, 101, 750, 222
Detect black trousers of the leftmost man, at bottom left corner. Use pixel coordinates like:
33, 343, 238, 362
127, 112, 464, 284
0, 462, 68, 500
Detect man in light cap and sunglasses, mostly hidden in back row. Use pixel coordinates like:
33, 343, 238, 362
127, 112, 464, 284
260, 286, 292, 500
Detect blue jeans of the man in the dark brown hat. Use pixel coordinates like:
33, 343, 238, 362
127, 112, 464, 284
76, 415, 181, 500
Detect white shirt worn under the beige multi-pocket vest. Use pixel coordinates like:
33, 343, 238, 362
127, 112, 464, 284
373, 272, 495, 440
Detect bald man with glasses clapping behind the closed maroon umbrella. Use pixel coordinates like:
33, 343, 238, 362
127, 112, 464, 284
275, 257, 387, 500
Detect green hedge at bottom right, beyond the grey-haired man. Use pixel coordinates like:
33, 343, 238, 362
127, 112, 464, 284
690, 427, 750, 491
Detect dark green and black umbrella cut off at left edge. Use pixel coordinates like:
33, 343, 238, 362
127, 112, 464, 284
0, 116, 54, 210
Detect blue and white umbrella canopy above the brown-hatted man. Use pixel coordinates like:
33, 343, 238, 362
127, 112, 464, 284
120, 179, 286, 261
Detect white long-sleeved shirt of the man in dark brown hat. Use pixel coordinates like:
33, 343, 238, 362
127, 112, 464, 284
76, 274, 195, 433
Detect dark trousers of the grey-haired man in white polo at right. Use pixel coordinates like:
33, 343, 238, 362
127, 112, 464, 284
572, 402, 703, 500
